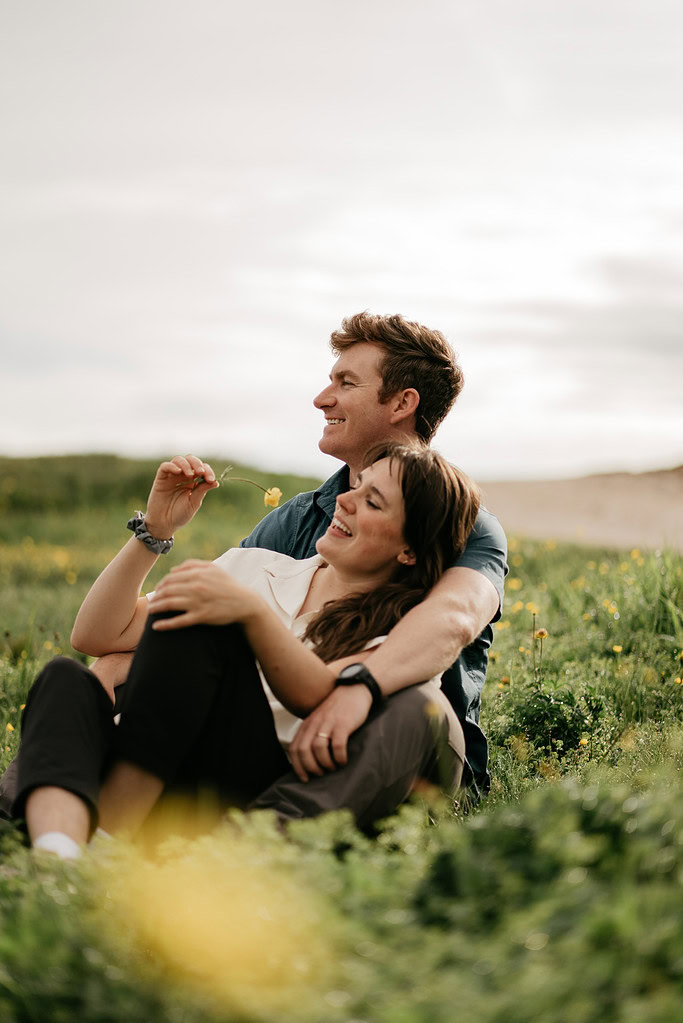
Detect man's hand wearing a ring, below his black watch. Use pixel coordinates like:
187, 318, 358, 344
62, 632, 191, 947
288, 684, 372, 782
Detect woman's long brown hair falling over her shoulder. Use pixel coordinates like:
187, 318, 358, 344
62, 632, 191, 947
305, 444, 481, 662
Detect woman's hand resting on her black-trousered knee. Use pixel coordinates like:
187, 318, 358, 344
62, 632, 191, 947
149, 559, 261, 632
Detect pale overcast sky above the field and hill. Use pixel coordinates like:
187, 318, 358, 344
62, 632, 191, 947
0, 0, 683, 480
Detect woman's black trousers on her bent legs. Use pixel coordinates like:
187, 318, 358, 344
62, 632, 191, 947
12, 616, 289, 821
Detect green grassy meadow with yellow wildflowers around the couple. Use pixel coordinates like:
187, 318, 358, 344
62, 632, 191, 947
0, 456, 683, 1023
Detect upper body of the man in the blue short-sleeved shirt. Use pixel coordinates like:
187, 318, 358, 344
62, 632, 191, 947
241, 312, 507, 796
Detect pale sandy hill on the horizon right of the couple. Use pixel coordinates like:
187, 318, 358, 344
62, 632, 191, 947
481, 465, 683, 550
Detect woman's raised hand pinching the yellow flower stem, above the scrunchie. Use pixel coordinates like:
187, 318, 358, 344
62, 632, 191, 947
144, 454, 218, 540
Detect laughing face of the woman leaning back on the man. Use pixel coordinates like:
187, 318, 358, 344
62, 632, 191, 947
316, 458, 415, 589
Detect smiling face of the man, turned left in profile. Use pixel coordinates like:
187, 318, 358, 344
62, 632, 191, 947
313, 342, 393, 472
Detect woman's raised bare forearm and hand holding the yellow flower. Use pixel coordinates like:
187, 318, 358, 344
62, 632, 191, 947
72, 455, 218, 657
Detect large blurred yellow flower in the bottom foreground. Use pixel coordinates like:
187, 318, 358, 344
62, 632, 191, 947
106, 834, 333, 1016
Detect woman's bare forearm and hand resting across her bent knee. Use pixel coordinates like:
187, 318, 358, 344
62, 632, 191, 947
149, 561, 336, 717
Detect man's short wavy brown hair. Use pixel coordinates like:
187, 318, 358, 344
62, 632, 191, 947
329, 311, 464, 442
